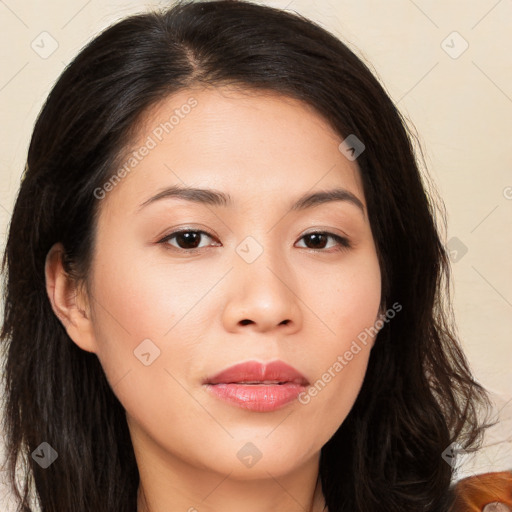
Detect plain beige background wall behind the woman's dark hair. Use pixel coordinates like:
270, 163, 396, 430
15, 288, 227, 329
0, 0, 512, 510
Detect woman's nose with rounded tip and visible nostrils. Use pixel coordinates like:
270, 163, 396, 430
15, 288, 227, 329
222, 242, 302, 334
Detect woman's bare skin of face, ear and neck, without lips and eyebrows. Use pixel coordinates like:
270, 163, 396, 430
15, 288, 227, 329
46, 87, 381, 512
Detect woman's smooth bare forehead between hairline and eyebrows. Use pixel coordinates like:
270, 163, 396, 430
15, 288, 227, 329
102, 87, 364, 216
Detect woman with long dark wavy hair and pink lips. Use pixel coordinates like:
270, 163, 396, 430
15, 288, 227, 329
2, 1, 494, 512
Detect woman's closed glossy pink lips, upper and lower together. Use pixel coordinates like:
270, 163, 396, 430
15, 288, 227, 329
204, 361, 309, 412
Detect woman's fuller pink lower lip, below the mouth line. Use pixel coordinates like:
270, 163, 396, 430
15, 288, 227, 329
206, 382, 306, 412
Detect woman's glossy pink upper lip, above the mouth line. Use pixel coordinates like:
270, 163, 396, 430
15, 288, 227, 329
205, 361, 309, 386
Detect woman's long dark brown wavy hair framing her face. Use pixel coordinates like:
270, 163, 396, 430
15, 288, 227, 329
1, 0, 489, 512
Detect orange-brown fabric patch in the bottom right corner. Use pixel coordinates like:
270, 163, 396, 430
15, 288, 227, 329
453, 471, 512, 512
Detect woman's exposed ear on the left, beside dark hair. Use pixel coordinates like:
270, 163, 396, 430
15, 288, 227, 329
45, 243, 96, 353
